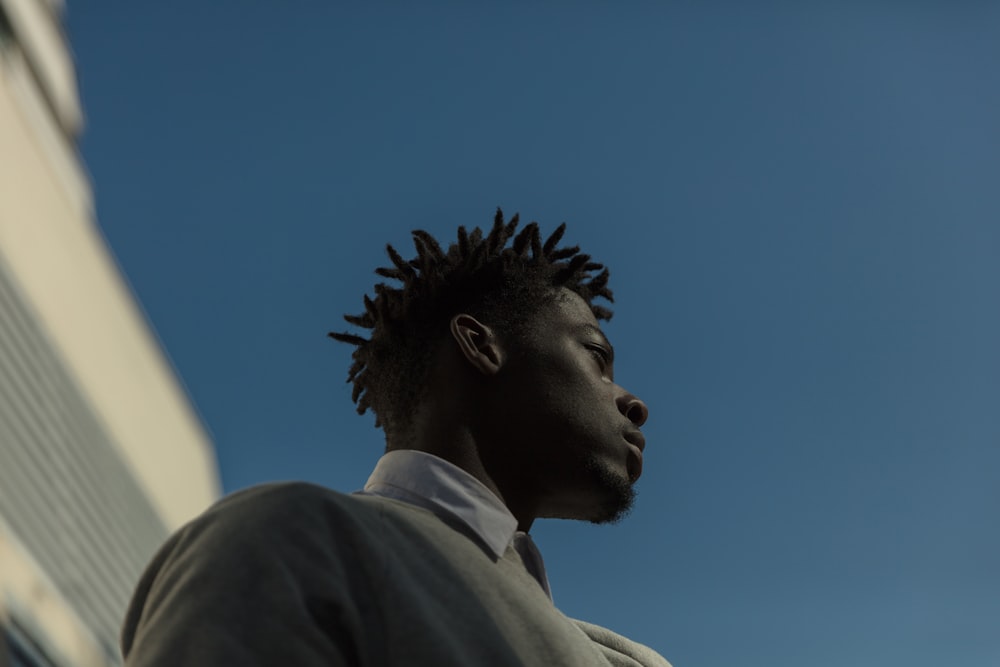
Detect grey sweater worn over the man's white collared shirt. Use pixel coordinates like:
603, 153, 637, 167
122, 483, 669, 667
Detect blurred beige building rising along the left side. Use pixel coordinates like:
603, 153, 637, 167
0, 0, 219, 667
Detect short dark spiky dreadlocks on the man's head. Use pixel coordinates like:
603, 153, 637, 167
328, 208, 614, 435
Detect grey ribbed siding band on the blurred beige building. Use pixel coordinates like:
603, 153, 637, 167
0, 265, 167, 655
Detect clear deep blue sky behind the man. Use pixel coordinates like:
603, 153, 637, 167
68, 0, 1000, 667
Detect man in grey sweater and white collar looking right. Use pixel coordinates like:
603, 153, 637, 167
122, 211, 669, 667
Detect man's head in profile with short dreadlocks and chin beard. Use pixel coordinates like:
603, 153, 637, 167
330, 210, 646, 523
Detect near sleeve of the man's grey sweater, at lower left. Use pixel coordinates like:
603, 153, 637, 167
122, 485, 373, 667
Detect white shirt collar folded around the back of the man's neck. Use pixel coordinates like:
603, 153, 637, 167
364, 449, 517, 558
